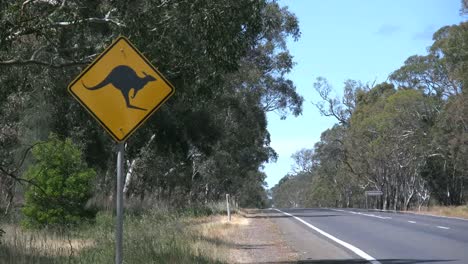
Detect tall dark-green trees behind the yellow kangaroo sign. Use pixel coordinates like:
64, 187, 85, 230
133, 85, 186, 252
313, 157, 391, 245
0, 0, 303, 222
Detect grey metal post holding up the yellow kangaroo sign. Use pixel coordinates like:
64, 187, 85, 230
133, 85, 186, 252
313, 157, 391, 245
115, 143, 125, 264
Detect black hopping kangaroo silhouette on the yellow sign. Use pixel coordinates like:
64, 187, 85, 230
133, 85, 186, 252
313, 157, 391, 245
81, 65, 156, 111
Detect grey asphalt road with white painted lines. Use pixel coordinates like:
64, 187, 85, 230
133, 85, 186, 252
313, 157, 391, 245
265, 209, 468, 264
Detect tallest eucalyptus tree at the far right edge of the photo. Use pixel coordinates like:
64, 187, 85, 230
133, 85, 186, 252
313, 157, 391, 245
390, 22, 468, 204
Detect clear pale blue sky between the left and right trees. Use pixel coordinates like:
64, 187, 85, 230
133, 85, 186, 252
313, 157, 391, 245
264, 0, 466, 188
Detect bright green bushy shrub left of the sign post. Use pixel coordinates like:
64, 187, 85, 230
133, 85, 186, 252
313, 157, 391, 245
23, 135, 96, 228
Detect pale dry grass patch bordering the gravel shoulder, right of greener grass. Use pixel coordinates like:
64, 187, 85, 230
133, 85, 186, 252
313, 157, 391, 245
190, 215, 249, 262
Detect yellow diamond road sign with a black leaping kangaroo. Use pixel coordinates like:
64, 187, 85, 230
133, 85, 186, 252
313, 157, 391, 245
68, 37, 174, 142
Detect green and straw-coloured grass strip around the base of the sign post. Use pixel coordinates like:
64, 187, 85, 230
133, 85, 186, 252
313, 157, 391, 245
0, 206, 229, 264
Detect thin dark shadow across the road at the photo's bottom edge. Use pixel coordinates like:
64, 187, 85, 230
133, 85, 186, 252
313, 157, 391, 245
243, 259, 455, 264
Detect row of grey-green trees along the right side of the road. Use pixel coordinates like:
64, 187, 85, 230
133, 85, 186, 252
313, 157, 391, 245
272, 21, 468, 210
